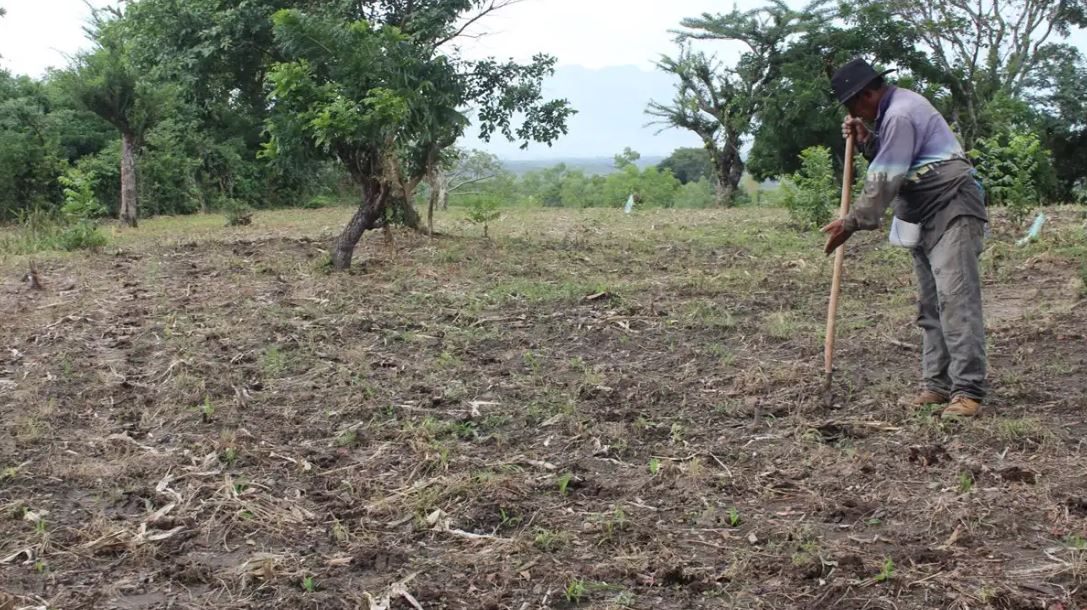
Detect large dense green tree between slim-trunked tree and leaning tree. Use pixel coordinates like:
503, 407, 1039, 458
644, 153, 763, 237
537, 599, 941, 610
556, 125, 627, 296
116, 0, 337, 212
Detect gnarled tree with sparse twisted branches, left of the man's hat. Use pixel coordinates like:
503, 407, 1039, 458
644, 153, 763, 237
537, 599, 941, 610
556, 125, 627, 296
647, 0, 826, 206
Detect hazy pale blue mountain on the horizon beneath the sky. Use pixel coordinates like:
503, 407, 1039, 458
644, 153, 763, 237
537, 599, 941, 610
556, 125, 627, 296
460, 65, 701, 160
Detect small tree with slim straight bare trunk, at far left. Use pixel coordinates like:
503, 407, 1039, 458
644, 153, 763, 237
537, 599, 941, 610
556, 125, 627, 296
64, 12, 167, 227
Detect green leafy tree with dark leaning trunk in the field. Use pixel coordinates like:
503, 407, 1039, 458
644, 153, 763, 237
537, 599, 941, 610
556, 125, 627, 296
266, 0, 572, 270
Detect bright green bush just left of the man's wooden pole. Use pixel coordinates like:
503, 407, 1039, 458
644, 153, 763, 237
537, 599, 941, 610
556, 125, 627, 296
782, 146, 840, 229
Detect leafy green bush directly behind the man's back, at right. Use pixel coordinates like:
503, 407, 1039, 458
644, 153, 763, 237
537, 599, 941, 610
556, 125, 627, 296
970, 132, 1049, 223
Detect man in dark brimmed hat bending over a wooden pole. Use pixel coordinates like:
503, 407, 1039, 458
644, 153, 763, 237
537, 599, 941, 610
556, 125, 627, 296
823, 59, 988, 418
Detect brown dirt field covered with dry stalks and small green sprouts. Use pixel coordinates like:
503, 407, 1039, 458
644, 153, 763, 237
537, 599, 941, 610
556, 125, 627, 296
0, 208, 1087, 610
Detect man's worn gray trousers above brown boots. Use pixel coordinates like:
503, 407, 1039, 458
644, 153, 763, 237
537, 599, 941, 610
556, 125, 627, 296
913, 216, 986, 400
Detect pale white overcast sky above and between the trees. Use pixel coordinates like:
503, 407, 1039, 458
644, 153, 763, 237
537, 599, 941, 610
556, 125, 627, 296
0, 0, 1087, 158
